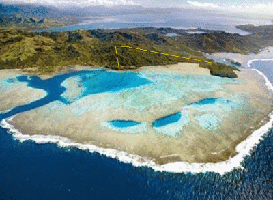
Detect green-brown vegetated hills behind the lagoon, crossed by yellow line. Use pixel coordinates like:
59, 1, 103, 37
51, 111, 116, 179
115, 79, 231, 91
0, 28, 237, 78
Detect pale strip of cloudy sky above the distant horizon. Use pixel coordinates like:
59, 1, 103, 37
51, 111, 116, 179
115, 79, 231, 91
0, 0, 273, 14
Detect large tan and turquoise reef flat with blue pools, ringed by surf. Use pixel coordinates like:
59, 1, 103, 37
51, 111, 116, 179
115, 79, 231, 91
6, 64, 272, 164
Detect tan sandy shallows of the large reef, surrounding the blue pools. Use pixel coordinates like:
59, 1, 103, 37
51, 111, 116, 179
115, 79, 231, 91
3, 64, 272, 170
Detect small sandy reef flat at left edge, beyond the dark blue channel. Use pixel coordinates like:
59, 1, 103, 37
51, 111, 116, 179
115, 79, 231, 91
0, 70, 46, 112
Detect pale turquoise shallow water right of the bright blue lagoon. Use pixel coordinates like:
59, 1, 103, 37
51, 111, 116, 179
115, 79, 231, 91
123, 72, 240, 113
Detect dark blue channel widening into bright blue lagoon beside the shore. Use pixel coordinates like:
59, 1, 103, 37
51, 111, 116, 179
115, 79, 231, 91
0, 69, 150, 118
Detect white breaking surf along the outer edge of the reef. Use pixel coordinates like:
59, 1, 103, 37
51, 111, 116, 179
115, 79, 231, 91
1, 59, 273, 175
